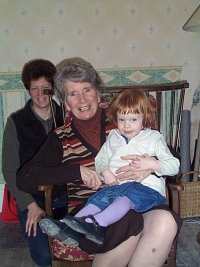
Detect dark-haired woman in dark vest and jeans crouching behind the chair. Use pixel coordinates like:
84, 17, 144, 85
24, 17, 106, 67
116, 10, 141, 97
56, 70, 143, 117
2, 59, 63, 266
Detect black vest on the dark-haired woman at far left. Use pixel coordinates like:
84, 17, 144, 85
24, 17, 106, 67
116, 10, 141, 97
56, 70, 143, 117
11, 100, 63, 166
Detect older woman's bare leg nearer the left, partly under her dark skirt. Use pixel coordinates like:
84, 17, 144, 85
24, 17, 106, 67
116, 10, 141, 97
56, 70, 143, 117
92, 235, 140, 267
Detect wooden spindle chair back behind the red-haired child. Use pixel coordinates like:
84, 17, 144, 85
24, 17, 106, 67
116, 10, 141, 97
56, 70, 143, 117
101, 80, 189, 152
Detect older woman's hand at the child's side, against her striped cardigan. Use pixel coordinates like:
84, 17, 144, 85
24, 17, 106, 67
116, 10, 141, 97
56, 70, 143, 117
80, 166, 101, 190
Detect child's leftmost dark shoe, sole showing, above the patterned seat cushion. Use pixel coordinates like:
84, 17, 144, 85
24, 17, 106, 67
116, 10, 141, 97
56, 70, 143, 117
39, 218, 81, 247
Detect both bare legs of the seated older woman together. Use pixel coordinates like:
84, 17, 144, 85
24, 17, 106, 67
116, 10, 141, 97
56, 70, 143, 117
92, 210, 177, 267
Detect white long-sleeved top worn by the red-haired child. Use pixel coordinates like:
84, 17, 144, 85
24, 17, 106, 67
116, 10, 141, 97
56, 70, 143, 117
95, 129, 180, 196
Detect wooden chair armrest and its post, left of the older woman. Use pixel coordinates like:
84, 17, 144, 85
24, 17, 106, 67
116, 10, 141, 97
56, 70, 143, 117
38, 185, 53, 216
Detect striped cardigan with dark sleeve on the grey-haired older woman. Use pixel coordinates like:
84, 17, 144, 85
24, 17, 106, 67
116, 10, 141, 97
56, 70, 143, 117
17, 112, 113, 193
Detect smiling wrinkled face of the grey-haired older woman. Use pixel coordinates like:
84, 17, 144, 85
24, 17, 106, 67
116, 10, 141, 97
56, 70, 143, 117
64, 81, 100, 120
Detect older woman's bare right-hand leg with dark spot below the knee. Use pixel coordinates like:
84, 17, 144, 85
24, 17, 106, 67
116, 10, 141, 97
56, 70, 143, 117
128, 210, 177, 267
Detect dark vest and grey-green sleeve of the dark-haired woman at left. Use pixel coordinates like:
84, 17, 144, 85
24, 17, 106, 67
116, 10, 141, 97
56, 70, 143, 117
2, 100, 63, 210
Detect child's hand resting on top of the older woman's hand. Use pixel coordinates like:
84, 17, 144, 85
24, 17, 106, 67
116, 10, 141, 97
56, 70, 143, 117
131, 154, 160, 171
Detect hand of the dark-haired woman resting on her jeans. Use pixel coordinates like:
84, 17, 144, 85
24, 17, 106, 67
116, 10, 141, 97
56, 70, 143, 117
26, 202, 45, 236
